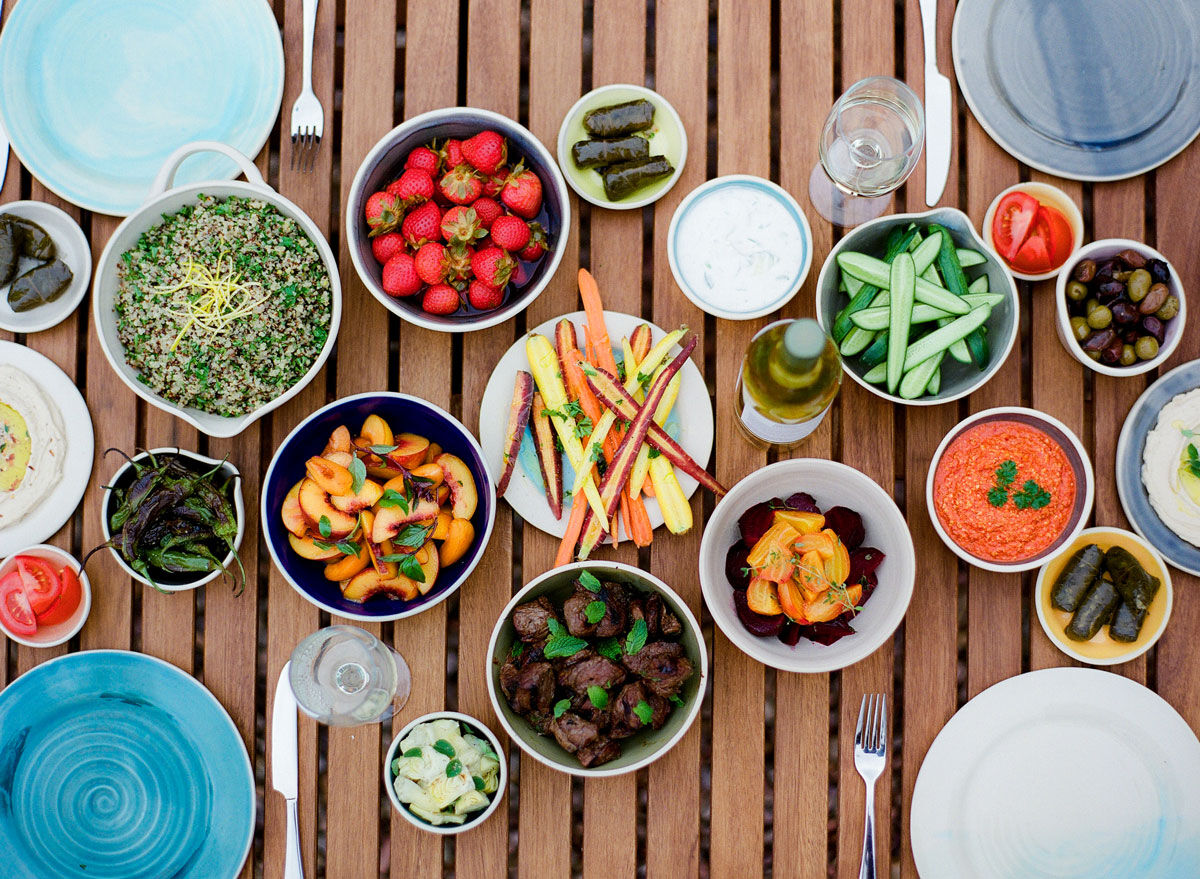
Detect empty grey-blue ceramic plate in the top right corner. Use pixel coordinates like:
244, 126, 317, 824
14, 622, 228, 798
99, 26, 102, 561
952, 0, 1200, 180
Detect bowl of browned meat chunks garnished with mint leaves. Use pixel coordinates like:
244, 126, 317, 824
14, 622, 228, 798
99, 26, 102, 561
487, 562, 708, 777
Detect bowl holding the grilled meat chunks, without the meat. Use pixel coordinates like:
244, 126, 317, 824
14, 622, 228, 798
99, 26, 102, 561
487, 562, 708, 778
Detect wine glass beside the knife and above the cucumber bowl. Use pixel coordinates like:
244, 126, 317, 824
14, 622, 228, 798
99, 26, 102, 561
809, 77, 925, 227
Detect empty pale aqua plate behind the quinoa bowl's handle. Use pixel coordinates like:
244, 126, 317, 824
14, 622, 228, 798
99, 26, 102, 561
0, 0, 283, 216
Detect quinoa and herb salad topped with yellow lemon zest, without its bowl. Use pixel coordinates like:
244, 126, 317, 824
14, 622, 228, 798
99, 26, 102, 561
113, 195, 332, 417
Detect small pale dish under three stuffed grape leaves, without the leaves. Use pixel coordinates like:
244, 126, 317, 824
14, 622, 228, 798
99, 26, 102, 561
557, 83, 688, 210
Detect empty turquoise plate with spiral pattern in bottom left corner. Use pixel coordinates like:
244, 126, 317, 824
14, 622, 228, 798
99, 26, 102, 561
0, 650, 254, 879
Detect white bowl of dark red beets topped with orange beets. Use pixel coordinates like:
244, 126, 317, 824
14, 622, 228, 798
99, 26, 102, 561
700, 458, 916, 672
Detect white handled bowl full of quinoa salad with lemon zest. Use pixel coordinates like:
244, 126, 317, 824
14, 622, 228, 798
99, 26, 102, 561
92, 142, 342, 437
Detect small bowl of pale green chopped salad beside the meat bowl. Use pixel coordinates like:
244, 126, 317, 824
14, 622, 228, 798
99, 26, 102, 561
383, 711, 509, 836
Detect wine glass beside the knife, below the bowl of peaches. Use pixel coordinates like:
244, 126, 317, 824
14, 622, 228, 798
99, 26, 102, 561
288, 626, 413, 726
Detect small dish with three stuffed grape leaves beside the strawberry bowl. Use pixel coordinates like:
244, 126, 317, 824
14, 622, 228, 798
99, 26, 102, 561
558, 84, 688, 210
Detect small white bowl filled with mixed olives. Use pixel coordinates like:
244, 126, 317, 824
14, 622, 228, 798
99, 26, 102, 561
1055, 238, 1187, 376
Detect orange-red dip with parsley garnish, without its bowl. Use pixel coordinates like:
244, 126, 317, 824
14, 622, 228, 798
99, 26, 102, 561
934, 420, 1076, 562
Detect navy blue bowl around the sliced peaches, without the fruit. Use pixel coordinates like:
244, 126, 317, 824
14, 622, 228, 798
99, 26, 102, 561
259, 390, 497, 622
